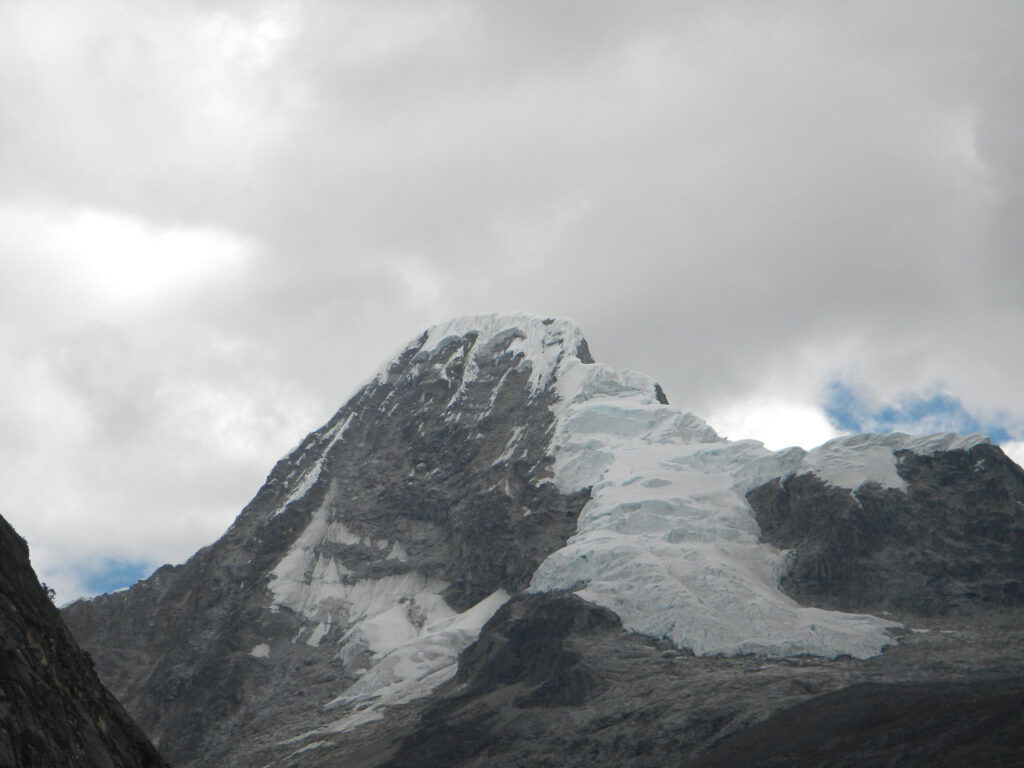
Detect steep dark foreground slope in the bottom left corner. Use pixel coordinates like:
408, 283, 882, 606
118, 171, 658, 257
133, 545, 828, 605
0, 517, 166, 768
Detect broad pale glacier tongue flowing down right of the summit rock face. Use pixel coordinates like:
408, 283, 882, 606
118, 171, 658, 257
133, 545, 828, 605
529, 359, 893, 657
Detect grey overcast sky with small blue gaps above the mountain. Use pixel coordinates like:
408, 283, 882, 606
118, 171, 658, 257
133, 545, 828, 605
0, 0, 1024, 600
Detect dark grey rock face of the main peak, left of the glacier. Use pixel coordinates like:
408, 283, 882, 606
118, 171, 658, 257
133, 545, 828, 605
65, 319, 589, 768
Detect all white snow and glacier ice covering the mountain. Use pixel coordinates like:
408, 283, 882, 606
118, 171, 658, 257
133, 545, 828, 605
253, 314, 985, 748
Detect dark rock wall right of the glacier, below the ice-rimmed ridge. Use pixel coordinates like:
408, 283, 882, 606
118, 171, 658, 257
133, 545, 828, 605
748, 444, 1024, 614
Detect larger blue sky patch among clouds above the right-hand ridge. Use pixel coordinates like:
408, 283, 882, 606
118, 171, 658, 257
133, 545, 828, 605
824, 380, 1014, 443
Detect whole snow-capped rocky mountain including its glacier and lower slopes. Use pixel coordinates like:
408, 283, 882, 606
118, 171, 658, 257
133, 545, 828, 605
65, 315, 1024, 768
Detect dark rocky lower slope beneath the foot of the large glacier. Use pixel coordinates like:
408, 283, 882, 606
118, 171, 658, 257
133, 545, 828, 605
380, 594, 1024, 768
